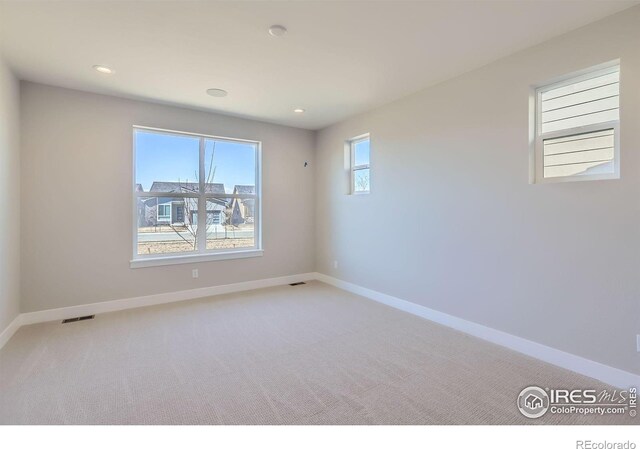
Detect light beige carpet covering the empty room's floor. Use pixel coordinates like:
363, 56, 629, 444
0, 282, 637, 424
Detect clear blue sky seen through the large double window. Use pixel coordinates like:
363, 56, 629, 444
135, 130, 255, 193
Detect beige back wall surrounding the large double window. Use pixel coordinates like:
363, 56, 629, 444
21, 82, 315, 312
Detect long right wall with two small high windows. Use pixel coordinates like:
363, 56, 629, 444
316, 7, 640, 373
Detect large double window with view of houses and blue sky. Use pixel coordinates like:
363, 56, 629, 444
131, 127, 262, 267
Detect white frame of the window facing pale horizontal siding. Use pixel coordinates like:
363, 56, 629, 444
529, 59, 622, 184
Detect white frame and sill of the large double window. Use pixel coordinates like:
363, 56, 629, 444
130, 125, 264, 268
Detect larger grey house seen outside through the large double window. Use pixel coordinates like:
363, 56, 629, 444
136, 181, 228, 227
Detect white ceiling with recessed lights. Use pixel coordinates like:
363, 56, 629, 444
0, 0, 637, 129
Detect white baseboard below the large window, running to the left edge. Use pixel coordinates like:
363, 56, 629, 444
0, 273, 315, 338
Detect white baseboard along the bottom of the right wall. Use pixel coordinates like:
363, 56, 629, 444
315, 273, 640, 388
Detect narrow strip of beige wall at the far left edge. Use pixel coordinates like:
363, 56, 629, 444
0, 55, 20, 332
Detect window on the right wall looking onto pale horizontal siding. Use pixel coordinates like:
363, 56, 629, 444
534, 64, 620, 182
